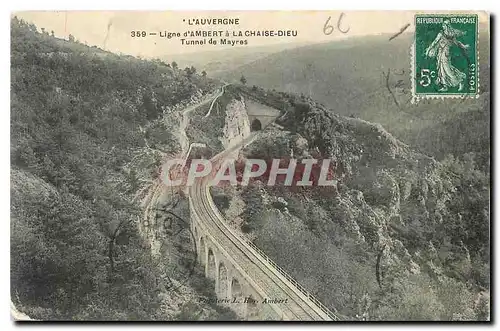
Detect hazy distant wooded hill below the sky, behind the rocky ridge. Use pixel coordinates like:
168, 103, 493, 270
216, 32, 490, 166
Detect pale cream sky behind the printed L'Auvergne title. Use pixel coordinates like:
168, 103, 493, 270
12, 11, 488, 58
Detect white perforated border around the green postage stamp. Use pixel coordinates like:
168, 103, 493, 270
410, 13, 481, 104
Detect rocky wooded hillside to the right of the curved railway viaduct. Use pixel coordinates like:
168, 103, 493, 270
212, 86, 490, 320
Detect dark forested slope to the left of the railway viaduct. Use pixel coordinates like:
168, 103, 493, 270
11, 18, 236, 320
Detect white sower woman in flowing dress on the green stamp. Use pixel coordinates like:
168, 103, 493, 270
425, 20, 469, 91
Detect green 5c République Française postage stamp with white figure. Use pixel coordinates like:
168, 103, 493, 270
411, 14, 479, 99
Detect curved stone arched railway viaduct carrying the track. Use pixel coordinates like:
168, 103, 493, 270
188, 135, 339, 321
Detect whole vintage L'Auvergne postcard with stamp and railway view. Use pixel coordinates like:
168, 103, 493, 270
10, 11, 491, 323
